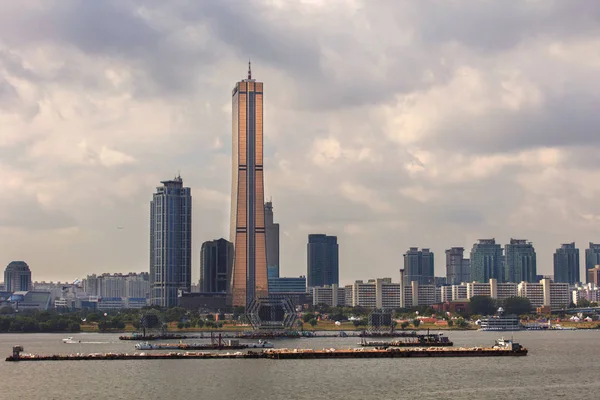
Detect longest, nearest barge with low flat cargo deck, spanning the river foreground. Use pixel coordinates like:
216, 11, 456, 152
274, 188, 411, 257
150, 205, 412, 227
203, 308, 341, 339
6, 339, 528, 362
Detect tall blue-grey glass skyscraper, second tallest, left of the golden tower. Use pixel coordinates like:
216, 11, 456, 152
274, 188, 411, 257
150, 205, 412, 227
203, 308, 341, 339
150, 176, 192, 307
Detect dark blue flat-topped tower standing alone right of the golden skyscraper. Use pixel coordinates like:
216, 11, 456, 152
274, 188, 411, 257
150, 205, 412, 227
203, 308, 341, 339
306, 234, 340, 288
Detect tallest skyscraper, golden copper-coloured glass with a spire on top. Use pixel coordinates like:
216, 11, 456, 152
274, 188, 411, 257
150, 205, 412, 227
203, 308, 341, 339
230, 63, 269, 307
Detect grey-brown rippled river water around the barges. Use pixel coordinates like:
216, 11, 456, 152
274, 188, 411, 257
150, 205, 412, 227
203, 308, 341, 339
0, 331, 600, 400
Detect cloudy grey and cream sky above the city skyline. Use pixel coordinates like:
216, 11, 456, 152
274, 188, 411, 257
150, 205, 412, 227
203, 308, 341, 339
0, 0, 600, 284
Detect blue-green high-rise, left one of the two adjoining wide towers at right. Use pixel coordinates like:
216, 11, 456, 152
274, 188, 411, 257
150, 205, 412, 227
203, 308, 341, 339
471, 239, 504, 283
